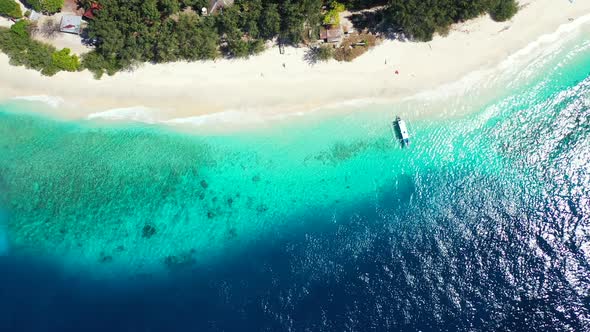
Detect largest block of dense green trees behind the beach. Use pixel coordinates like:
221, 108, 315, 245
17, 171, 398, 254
84, 0, 332, 75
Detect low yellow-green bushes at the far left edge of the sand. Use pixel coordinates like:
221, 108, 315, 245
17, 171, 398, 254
0, 21, 80, 76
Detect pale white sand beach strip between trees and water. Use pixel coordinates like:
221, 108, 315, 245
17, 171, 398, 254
0, 0, 590, 126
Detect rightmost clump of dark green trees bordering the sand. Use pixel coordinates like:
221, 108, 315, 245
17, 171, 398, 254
385, 0, 518, 41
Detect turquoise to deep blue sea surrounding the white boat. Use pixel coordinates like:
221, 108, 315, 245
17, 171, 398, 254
0, 22, 590, 331
